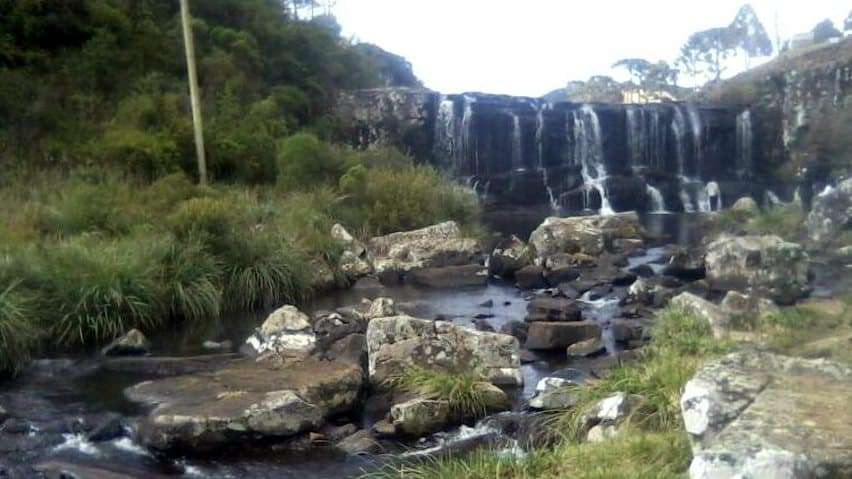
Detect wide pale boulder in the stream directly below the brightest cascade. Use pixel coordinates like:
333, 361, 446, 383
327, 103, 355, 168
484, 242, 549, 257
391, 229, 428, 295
530, 212, 644, 262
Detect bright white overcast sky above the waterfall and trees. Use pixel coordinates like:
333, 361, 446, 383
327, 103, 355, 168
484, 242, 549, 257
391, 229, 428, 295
335, 0, 852, 96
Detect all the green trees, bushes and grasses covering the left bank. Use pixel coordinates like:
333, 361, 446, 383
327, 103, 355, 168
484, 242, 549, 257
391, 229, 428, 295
0, 0, 477, 374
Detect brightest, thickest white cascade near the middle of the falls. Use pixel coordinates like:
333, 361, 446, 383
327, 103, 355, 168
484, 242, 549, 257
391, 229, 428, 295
573, 105, 615, 215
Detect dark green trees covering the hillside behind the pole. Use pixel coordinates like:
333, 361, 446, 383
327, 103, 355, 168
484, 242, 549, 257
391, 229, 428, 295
0, 0, 416, 181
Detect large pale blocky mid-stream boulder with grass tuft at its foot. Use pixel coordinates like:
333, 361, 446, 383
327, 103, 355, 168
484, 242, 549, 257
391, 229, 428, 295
367, 316, 523, 385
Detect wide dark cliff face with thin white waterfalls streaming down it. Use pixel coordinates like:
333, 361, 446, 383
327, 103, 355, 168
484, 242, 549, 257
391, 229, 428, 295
339, 88, 764, 215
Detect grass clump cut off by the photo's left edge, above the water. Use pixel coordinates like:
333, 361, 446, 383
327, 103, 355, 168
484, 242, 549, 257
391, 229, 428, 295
0, 284, 40, 376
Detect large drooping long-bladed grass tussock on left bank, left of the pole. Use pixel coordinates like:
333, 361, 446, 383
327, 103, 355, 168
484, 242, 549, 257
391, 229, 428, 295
33, 238, 163, 346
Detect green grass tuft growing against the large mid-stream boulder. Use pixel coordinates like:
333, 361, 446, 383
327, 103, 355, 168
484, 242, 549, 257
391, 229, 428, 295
390, 367, 488, 419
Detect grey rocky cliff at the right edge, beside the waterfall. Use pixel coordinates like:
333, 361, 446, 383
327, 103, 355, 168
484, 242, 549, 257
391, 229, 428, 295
710, 37, 852, 199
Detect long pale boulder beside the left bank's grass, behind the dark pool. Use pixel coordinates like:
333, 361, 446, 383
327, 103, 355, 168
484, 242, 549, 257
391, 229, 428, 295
367, 221, 480, 275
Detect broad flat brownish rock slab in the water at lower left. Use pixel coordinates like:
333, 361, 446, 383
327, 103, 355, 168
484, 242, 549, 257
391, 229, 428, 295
125, 359, 362, 453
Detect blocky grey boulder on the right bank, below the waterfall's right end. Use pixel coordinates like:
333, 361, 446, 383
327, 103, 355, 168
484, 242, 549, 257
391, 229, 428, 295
706, 236, 810, 304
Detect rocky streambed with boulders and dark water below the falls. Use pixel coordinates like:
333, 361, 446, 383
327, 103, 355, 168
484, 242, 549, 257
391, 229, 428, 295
0, 190, 848, 478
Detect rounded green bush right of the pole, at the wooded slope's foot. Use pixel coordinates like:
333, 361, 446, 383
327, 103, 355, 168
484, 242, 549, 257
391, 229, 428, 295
278, 133, 349, 190
